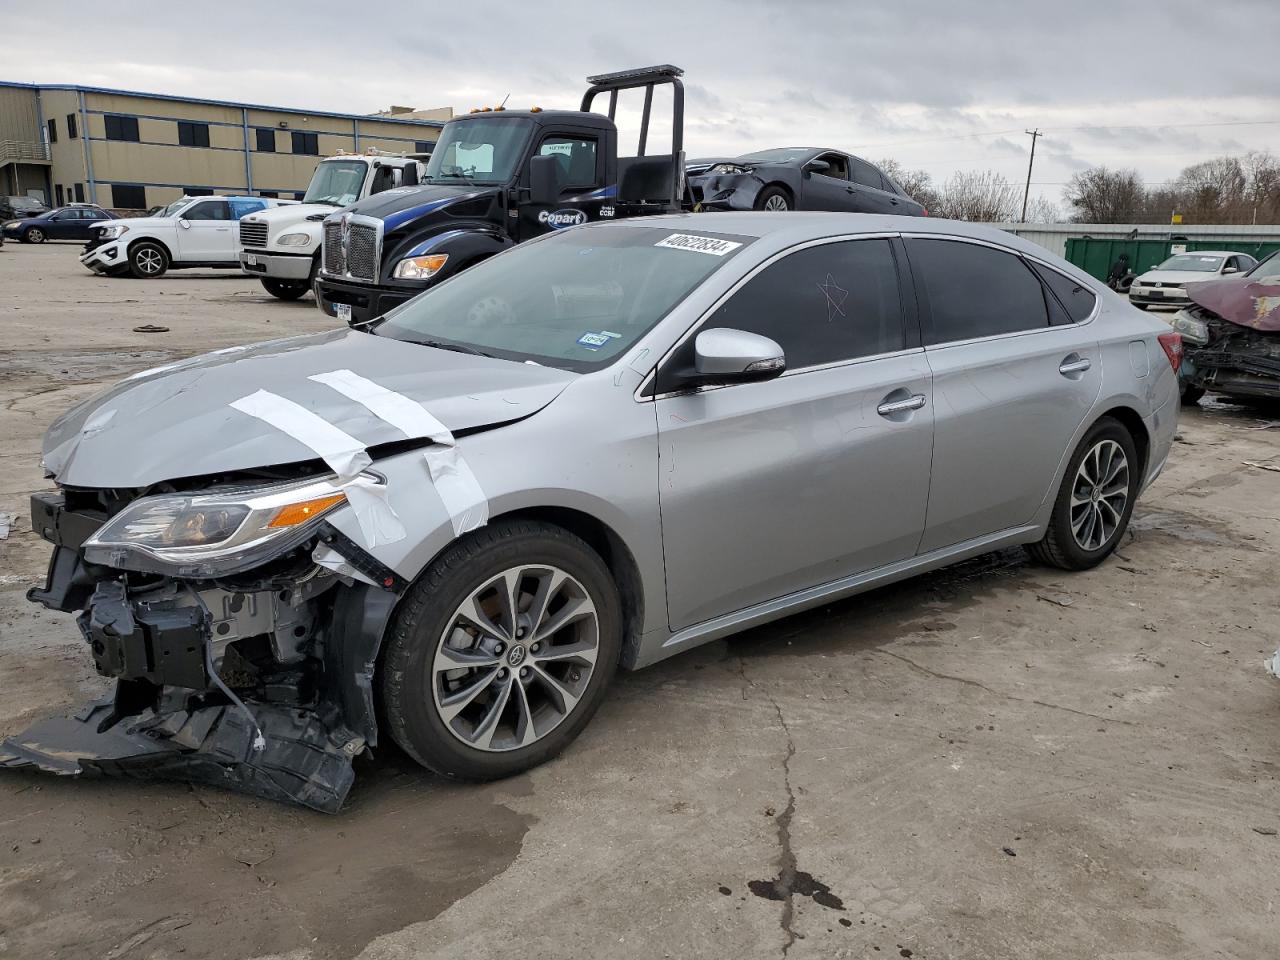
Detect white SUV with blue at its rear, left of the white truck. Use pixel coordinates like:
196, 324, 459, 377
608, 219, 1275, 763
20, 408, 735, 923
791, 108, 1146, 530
81, 197, 294, 279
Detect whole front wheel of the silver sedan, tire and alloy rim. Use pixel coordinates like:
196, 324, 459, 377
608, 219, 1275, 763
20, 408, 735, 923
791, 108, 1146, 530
379, 521, 622, 781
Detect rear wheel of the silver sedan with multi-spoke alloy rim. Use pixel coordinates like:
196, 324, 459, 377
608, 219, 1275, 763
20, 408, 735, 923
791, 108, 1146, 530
1028, 417, 1142, 570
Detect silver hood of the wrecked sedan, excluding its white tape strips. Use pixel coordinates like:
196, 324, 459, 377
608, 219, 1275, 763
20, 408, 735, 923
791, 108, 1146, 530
44, 329, 575, 488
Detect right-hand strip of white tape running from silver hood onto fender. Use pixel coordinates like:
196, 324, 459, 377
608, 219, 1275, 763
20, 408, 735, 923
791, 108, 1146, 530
310, 370, 489, 536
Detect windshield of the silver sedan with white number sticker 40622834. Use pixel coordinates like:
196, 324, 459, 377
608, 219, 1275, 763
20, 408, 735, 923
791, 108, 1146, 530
374, 225, 751, 371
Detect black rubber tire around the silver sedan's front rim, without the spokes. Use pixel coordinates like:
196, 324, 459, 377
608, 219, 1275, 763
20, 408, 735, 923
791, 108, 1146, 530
379, 520, 622, 781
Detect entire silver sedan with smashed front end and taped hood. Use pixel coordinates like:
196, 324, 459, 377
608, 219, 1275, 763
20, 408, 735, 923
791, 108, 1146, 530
0, 214, 1180, 810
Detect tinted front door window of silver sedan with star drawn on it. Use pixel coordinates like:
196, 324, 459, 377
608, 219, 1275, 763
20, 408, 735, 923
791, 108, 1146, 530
690, 239, 906, 370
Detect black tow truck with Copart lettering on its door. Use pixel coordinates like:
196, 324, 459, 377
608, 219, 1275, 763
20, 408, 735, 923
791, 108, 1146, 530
315, 64, 685, 324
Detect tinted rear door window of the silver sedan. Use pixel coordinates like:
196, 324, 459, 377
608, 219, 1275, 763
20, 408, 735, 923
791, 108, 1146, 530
906, 237, 1048, 344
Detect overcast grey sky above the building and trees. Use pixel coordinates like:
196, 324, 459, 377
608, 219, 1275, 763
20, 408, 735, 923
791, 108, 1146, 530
10, 0, 1280, 209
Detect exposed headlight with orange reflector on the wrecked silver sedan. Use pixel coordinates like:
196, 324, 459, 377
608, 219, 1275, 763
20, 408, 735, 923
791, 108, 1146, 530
84, 476, 347, 579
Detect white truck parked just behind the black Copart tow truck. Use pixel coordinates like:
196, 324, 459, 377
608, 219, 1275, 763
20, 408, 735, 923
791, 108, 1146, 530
239, 154, 426, 300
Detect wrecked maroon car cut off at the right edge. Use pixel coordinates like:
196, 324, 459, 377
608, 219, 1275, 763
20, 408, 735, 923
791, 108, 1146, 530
1170, 252, 1280, 403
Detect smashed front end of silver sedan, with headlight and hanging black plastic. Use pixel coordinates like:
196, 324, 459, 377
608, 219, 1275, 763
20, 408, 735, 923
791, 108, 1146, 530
0, 475, 404, 813
